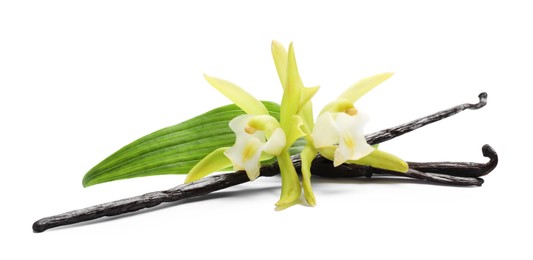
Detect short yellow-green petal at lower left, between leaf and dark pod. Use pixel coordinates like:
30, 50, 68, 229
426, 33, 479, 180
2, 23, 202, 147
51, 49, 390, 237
185, 147, 232, 183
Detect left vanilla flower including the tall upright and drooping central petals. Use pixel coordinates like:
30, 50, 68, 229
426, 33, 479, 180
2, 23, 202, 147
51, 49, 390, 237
185, 42, 318, 206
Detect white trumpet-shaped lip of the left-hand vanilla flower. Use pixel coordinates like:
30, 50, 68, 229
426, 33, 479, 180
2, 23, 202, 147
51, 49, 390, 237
224, 115, 286, 180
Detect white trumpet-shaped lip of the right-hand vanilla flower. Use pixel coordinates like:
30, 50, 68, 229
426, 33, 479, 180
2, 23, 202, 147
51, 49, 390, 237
312, 109, 374, 166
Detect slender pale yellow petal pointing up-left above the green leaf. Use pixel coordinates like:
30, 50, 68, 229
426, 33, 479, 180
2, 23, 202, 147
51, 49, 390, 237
204, 74, 268, 115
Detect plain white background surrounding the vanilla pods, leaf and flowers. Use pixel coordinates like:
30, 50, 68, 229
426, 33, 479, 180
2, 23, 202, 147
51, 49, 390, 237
0, 0, 533, 259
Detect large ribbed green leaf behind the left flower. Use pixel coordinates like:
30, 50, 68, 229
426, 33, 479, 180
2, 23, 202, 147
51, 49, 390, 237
82, 102, 290, 187
